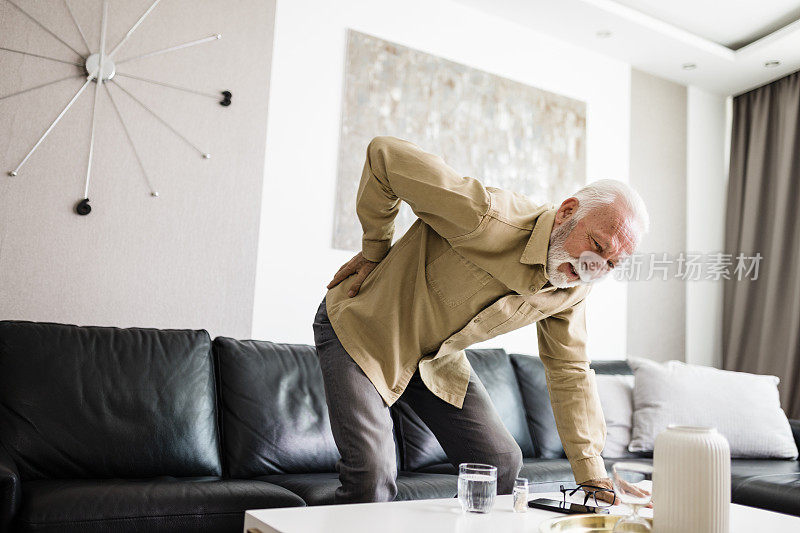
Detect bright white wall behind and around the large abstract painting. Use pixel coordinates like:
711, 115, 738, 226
252, 0, 630, 358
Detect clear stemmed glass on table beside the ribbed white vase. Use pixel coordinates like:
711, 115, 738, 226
611, 463, 653, 533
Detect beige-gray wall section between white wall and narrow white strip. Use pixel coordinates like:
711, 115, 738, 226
627, 69, 687, 361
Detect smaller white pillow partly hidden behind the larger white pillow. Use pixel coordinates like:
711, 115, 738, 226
594, 374, 633, 458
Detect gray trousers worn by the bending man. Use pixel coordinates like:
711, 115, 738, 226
314, 298, 522, 503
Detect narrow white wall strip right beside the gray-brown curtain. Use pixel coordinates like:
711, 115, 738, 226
686, 87, 728, 368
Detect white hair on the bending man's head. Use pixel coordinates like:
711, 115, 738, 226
572, 180, 650, 238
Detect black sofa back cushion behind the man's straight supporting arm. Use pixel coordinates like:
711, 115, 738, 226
511, 353, 633, 458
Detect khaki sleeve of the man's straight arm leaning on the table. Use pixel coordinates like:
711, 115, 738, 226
537, 299, 608, 483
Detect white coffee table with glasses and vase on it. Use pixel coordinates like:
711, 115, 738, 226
244, 492, 800, 533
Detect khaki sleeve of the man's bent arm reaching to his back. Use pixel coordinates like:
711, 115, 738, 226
356, 136, 490, 261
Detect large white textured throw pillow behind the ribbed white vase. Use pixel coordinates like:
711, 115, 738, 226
628, 358, 797, 459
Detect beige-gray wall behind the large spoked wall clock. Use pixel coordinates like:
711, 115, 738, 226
0, 0, 275, 337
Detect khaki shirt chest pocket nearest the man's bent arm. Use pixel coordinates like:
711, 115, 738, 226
425, 248, 492, 307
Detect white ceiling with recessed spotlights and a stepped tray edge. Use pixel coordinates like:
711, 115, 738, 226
456, 0, 800, 95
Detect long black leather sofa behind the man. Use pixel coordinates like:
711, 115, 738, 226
0, 320, 800, 533
